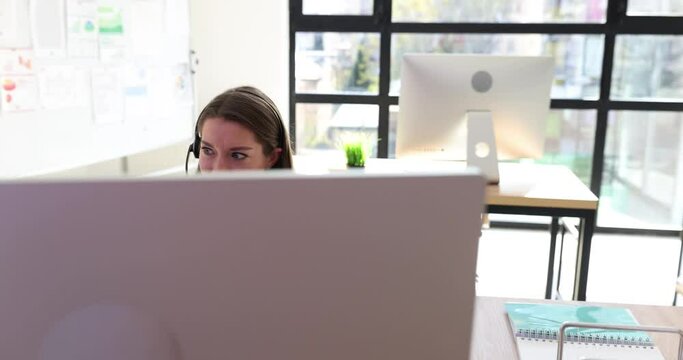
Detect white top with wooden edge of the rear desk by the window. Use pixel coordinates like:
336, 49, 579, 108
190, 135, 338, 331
294, 156, 598, 210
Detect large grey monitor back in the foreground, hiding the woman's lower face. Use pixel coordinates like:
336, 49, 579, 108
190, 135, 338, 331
0, 171, 484, 360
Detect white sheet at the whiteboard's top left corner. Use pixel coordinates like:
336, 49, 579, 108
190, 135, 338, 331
0, 0, 31, 48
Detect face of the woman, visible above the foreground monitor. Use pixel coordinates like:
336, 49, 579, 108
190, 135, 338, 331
199, 117, 282, 172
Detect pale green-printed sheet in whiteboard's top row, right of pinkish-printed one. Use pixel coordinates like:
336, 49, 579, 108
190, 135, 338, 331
97, 5, 126, 63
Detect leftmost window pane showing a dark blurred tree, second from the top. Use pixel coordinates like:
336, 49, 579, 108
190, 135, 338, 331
295, 32, 379, 94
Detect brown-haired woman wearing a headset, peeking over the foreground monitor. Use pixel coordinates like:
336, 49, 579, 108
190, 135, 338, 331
185, 86, 292, 172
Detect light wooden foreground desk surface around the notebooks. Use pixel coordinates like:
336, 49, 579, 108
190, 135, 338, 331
470, 296, 683, 360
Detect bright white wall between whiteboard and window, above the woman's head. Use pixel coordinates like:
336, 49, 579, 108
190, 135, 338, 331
190, 0, 289, 126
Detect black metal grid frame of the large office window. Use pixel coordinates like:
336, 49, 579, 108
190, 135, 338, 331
289, 0, 683, 236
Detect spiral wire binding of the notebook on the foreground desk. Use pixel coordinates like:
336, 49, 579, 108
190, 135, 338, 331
515, 329, 655, 347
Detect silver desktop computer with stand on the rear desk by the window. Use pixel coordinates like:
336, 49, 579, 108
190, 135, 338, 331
396, 54, 554, 183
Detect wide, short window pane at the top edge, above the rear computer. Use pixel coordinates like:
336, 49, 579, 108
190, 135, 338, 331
392, 0, 608, 23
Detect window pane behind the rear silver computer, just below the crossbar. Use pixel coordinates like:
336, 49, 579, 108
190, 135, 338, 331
389, 105, 597, 186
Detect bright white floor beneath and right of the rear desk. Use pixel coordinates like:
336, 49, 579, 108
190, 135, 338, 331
477, 228, 682, 305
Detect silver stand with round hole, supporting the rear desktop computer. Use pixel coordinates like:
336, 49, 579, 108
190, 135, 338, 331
466, 110, 500, 184
